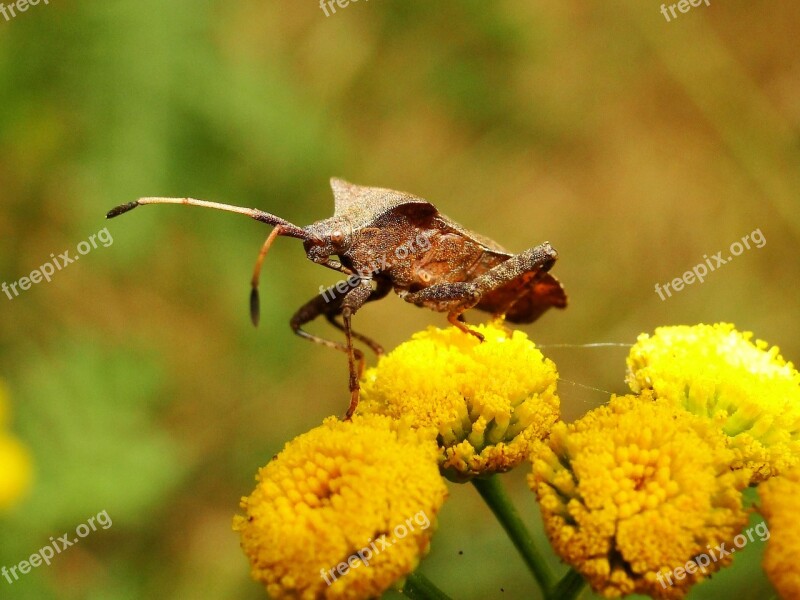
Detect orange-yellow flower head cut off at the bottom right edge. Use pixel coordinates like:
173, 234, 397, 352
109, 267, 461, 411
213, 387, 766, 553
758, 467, 800, 600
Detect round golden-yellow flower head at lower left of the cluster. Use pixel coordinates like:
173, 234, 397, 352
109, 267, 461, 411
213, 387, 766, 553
234, 415, 447, 599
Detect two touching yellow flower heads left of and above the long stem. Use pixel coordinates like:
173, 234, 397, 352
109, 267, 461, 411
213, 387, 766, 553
234, 325, 559, 598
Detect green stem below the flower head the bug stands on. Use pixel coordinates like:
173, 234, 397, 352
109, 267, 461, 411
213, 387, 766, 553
471, 475, 555, 597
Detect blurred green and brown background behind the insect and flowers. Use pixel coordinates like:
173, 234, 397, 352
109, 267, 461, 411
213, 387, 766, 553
0, 0, 800, 599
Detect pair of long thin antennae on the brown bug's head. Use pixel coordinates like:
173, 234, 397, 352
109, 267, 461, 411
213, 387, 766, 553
106, 198, 316, 325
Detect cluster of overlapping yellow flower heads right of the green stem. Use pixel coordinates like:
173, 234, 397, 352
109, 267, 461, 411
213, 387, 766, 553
529, 323, 800, 598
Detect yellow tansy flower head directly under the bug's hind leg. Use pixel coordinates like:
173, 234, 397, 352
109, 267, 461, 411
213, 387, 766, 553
360, 324, 559, 481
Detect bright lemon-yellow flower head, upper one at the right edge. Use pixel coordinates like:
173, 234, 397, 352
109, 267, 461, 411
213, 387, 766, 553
627, 323, 800, 482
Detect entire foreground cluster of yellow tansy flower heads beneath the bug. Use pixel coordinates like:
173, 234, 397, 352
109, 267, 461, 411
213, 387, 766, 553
234, 323, 800, 599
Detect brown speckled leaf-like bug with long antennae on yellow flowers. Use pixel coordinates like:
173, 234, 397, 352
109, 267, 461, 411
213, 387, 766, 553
106, 178, 567, 419
